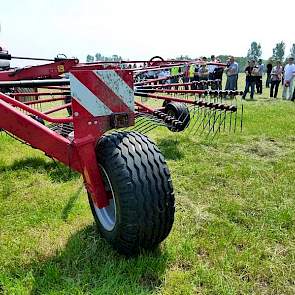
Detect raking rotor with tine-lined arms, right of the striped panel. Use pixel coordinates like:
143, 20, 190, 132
129, 61, 243, 140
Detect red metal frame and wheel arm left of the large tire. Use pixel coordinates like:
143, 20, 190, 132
0, 60, 134, 208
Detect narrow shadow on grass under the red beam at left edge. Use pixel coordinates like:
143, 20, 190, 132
0, 157, 80, 182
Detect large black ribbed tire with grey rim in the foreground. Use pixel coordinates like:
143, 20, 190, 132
89, 132, 175, 256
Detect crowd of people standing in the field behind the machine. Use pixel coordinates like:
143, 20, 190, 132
136, 55, 295, 101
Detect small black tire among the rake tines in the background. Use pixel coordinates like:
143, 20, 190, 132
163, 101, 190, 132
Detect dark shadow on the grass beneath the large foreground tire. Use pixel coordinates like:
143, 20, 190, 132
11, 225, 168, 294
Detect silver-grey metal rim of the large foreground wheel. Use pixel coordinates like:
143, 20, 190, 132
94, 165, 117, 231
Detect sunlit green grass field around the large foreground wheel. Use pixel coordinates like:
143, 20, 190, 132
0, 78, 295, 295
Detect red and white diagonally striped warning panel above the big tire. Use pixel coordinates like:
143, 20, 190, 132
70, 70, 134, 117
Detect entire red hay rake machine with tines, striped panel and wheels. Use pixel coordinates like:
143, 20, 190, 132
0, 52, 241, 255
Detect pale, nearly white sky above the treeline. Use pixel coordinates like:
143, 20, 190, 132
0, 0, 295, 64
